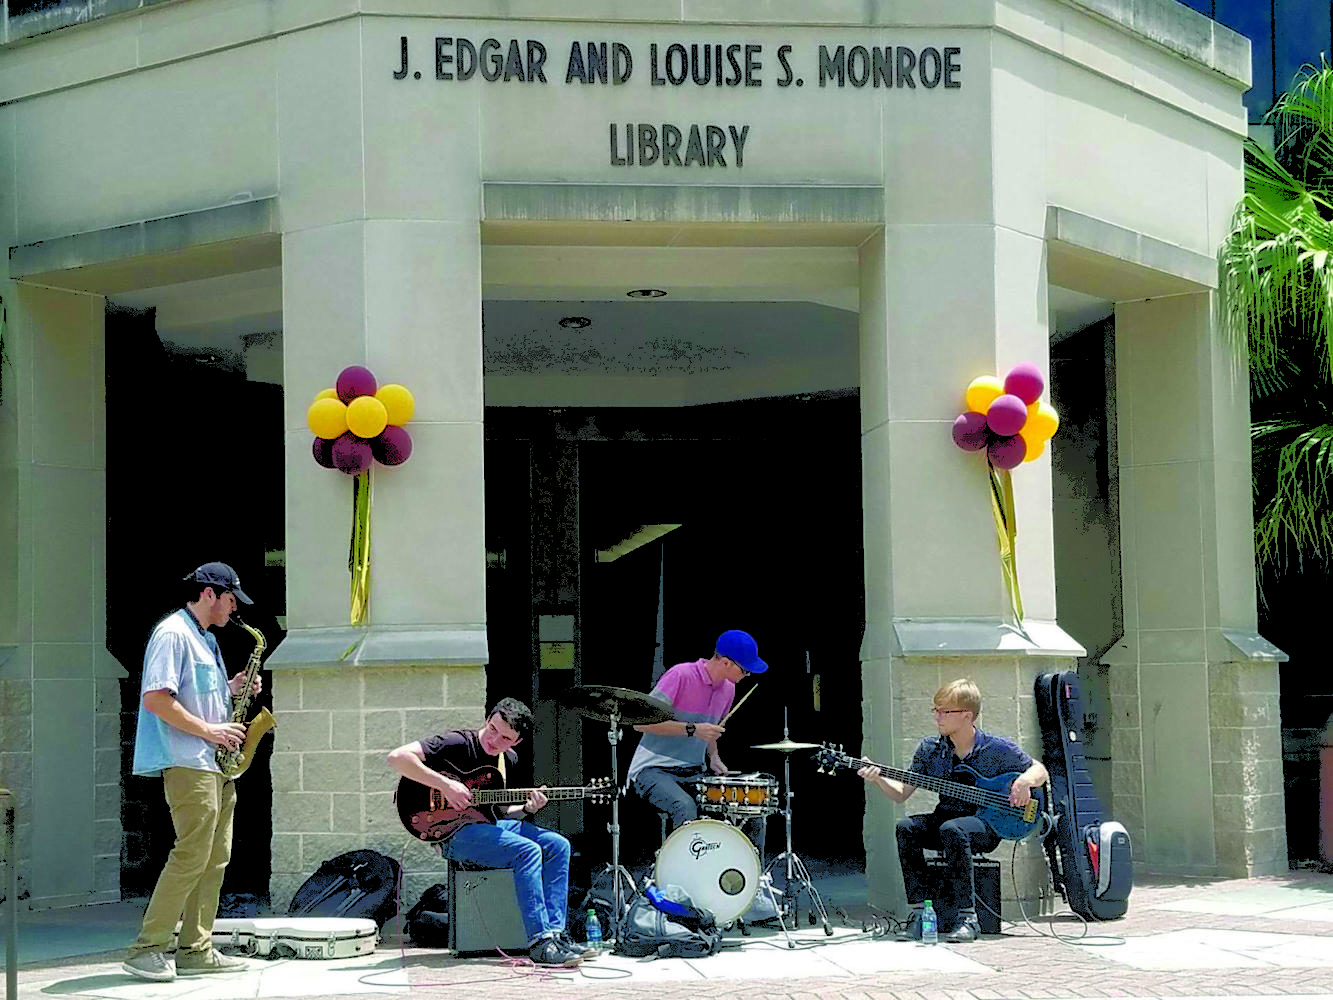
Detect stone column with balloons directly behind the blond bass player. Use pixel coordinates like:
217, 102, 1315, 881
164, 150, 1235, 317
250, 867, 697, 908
861, 224, 1081, 912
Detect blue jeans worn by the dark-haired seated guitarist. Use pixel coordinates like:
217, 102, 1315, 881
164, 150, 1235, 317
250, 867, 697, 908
440, 820, 569, 945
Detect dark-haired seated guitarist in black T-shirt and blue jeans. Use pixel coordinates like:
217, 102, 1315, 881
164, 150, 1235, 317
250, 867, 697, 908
389, 697, 592, 965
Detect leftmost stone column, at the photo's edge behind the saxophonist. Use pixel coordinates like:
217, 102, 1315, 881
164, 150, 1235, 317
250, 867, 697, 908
0, 284, 127, 908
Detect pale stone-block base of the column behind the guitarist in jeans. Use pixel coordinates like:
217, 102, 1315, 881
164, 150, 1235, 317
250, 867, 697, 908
269, 667, 487, 912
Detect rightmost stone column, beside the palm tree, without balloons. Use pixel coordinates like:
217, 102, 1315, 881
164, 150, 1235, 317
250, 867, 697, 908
1104, 293, 1286, 876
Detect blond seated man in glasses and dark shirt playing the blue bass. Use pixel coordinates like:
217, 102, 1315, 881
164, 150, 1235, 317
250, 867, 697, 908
857, 679, 1046, 944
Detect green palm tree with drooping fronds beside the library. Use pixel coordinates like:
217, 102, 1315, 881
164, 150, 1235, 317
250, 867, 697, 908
1218, 64, 1333, 576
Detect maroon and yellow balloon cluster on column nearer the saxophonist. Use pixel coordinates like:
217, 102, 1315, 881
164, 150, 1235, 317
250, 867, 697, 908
305, 364, 416, 476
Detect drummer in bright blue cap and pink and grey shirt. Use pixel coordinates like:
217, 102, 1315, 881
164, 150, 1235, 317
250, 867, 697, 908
629, 629, 768, 857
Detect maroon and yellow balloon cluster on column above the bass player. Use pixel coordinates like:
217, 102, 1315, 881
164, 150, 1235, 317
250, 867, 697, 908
953, 364, 1060, 469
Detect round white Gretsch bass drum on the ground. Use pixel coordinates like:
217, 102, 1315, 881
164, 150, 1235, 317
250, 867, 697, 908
653, 820, 760, 924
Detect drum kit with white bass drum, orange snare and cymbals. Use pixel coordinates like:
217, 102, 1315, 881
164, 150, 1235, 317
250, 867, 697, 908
560, 684, 833, 948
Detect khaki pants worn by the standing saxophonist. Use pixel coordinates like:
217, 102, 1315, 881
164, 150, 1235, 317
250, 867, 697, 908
129, 768, 236, 957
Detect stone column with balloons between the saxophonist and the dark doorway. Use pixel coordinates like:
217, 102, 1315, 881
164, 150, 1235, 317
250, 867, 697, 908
268, 19, 487, 907
